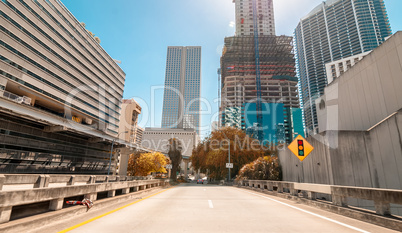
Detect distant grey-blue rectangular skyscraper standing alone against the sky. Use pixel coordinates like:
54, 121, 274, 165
162, 46, 201, 135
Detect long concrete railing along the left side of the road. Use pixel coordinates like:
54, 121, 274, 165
0, 175, 169, 223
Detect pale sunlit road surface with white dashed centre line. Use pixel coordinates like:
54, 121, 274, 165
55, 184, 395, 233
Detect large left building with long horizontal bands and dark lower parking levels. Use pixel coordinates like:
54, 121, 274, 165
0, 0, 126, 174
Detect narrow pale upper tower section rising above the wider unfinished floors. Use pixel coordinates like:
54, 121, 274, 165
233, 0, 275, 36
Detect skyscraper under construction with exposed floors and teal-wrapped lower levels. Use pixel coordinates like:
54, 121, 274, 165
220, 0, 304, 143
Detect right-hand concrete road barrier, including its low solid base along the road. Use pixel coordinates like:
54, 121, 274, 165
235, 180, 402, 231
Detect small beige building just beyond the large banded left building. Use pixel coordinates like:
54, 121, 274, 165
119, 99, 141, 143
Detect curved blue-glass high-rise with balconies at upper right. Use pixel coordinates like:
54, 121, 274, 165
295, 0, 391, 134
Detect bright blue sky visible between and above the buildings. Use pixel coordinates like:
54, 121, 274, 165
62, 0, 402, 137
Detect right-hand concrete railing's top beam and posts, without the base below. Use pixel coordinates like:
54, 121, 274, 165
236, 180, 402, 215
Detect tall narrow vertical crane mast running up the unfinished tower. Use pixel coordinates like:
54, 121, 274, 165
252, 0, 264, 142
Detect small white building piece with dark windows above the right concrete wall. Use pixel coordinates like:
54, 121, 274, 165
325, 51, 371, 84
